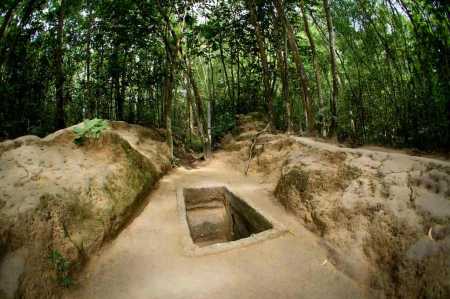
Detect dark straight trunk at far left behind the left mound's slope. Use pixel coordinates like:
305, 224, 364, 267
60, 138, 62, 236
55, 0, 66, 129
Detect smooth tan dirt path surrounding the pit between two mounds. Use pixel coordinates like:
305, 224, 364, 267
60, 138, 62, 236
65, 153, 366, 299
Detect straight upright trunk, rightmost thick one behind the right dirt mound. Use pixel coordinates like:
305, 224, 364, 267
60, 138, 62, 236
323, 0, 339, 136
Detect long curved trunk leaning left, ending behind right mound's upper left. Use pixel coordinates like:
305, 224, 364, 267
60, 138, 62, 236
274, 0, 315, 134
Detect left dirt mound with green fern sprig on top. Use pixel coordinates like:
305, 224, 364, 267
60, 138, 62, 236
0, 122, 170, 298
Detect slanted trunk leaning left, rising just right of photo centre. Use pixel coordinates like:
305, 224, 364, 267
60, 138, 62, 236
246, 0, 275, 126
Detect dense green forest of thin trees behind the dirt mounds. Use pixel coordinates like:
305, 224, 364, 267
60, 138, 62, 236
0, 0, 450, 156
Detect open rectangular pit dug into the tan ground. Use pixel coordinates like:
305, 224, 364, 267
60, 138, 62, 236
183, 187, 273, 246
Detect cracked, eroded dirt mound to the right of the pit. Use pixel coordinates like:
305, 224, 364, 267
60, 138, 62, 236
223, 120, 450, 298
